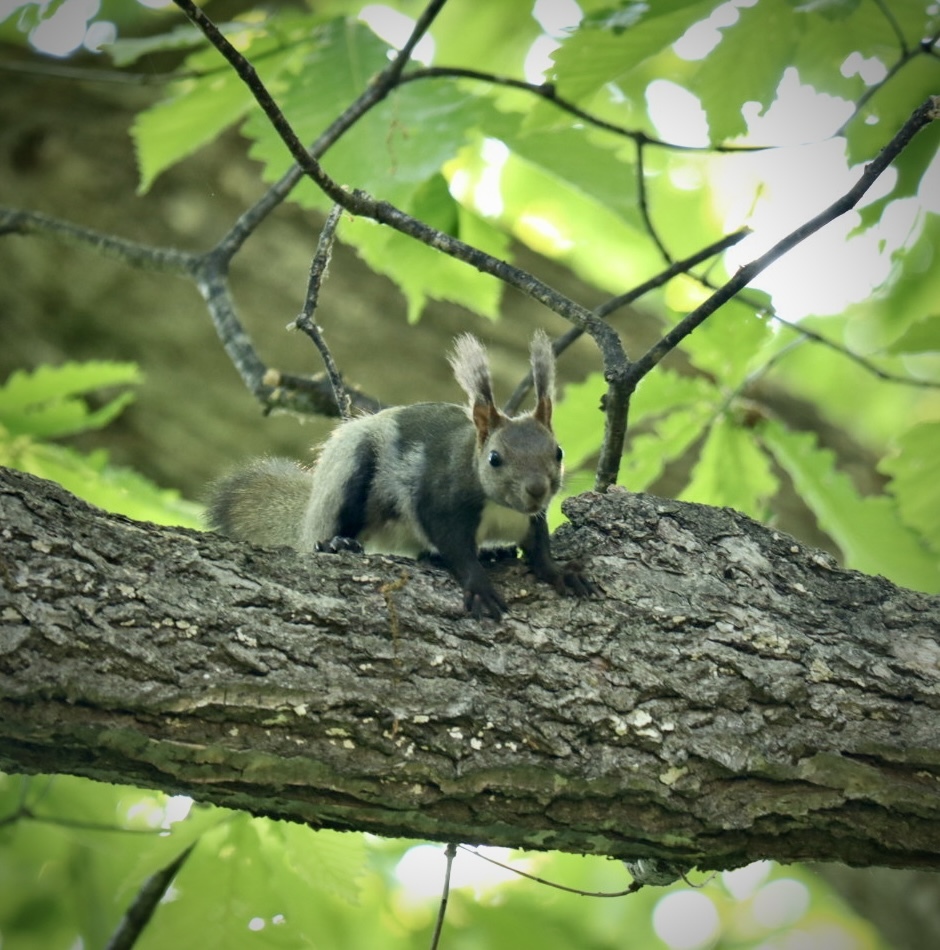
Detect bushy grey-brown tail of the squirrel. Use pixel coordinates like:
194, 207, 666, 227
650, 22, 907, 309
206, 458, 312, 548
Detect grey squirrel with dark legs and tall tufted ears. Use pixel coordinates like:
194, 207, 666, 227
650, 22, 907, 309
207, 331, 595, 620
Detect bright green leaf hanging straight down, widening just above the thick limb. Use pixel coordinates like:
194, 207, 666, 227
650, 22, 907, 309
679, 415, 780, 520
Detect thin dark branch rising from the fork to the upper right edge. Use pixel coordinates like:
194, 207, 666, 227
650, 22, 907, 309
628, 96, 940, 387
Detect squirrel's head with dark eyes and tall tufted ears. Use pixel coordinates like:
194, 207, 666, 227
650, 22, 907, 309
450, 330, 564, 515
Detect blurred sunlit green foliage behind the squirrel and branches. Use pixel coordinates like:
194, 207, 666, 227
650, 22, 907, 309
0, 0, 940, 950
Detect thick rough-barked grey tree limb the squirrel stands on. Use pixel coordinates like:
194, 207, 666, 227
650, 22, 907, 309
0, 469, 940, 868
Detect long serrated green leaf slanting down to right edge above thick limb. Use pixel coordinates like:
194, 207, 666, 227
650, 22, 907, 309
758, 421, 940, 593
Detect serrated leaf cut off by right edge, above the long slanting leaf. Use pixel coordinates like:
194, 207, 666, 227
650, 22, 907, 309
878, 422, 940, 554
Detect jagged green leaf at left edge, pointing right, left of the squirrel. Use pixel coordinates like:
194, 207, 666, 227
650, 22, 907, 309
0, 362, 140, 439
